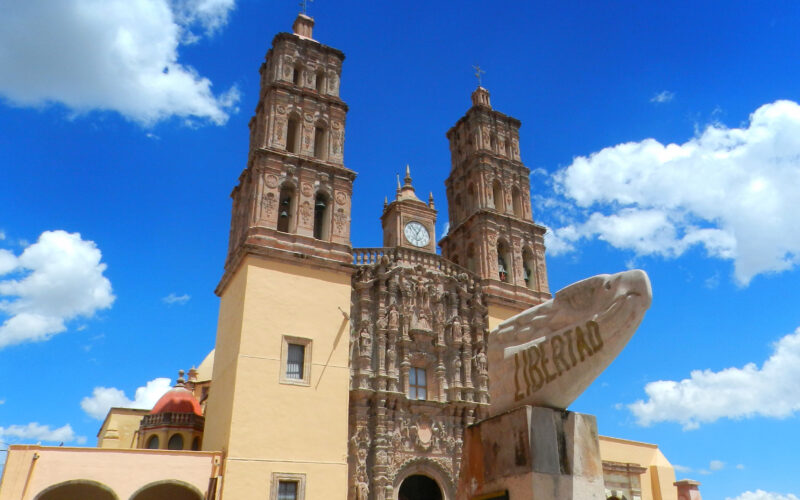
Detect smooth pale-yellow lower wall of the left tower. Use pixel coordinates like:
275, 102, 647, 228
203, 255, 351, 498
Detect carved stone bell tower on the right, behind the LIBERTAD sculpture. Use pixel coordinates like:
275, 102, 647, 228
439, 86, 550, 329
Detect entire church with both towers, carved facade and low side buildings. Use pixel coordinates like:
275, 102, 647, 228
0, 14, 688, 500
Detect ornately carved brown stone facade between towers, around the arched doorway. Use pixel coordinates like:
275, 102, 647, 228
350, 260, 489, 500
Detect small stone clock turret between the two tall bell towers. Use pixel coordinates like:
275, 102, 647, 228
381, 165, 436, 253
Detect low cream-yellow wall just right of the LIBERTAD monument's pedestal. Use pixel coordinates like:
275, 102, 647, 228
600, 436, 678, 500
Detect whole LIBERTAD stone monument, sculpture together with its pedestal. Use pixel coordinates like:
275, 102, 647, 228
458, 270, 652, 500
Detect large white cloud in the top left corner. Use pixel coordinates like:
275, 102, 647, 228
0, 0, 239, 125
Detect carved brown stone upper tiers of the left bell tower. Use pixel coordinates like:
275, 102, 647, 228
226, 14, 355, 267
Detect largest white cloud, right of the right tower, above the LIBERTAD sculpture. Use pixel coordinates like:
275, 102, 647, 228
546, 101, 800, 285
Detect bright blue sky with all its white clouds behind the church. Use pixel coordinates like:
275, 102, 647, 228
0, 0, 800, 500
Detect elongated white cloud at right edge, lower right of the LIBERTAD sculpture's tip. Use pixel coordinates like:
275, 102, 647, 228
628, 328, 800, 428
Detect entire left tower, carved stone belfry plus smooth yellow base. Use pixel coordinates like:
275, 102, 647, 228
203, 14, 355, 499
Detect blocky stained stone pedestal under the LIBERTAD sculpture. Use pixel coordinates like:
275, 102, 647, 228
457, 406, 605, 500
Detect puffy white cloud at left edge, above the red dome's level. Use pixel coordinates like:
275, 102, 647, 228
0, 231, 115, 348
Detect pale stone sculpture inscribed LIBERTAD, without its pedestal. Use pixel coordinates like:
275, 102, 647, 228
488, 269, 652, 415
